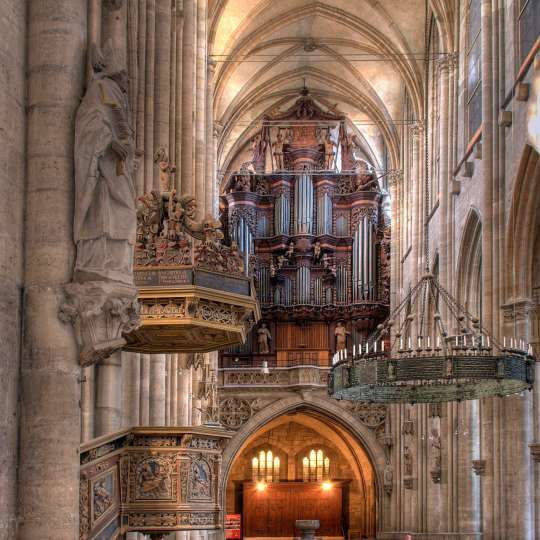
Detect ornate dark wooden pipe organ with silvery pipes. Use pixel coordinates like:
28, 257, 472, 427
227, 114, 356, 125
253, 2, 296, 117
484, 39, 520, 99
217, 88, 390, 367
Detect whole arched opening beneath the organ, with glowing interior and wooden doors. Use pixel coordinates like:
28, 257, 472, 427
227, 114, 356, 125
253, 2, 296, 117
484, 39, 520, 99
222, 398, 385, 539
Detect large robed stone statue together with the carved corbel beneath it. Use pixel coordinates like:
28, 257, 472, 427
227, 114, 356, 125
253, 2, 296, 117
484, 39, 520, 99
59, 41, 139, 366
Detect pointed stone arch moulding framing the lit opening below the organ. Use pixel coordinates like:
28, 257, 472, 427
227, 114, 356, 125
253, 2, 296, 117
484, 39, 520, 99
220, 393, 389, 531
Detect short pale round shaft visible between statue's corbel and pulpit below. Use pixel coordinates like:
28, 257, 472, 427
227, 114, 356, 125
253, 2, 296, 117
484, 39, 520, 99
94, 352, 122, 437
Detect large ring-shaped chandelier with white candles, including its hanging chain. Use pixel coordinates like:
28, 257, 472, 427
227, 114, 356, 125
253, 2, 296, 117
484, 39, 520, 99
328, 2, 535, 403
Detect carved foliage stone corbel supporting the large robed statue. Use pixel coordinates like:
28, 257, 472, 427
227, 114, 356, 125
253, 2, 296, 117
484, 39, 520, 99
59, 281, 139, 366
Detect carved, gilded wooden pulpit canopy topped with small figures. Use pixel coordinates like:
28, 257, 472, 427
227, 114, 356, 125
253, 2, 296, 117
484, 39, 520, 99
125, 191, 260, 353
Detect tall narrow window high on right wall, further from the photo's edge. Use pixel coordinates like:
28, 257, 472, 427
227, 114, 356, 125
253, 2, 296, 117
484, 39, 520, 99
465, 0, 482, 139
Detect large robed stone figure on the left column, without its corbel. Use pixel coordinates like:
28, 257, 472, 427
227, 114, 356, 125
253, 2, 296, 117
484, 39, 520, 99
73, 41, 137, 285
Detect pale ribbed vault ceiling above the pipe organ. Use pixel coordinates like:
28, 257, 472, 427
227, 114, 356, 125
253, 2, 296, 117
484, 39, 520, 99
210, 0, 442, 177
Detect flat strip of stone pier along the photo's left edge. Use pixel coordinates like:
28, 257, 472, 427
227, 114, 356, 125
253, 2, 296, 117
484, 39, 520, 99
0, 0, 26, 540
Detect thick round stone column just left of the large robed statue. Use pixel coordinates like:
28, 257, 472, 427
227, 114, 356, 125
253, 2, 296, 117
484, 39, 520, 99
18, 0, 88, 540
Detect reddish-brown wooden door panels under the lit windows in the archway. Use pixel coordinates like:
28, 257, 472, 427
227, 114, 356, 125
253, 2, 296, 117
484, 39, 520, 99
242, 482, 344, 538
